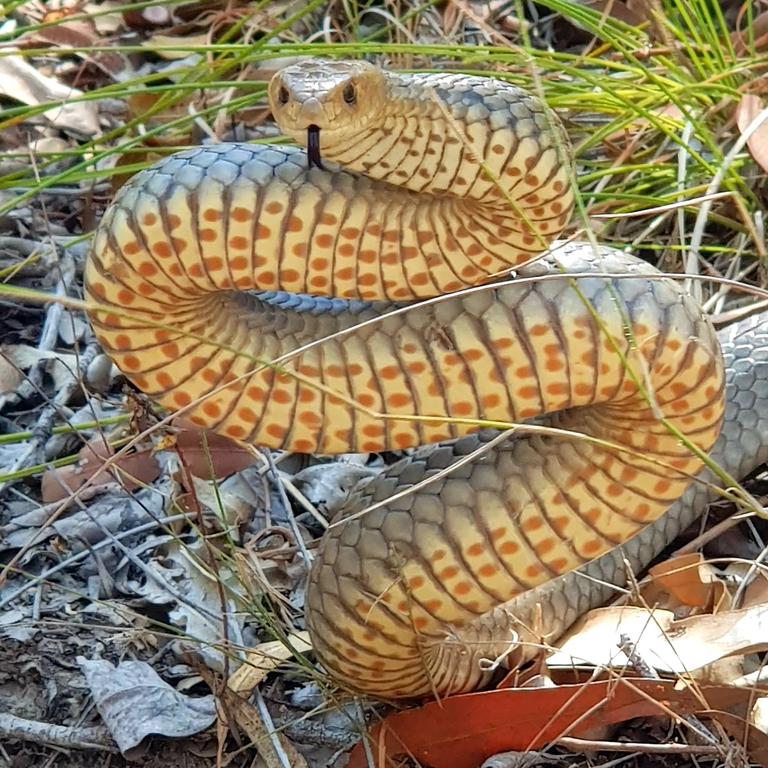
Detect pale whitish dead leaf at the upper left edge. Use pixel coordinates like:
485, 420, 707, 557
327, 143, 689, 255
0, 56, 99, 136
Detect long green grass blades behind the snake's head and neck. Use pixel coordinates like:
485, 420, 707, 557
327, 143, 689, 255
0, 2, 766, 262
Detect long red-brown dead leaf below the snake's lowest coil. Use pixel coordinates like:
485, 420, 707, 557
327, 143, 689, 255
347, 678, 752, 768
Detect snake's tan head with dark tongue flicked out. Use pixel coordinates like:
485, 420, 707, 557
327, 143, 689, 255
269, 59, 386, 166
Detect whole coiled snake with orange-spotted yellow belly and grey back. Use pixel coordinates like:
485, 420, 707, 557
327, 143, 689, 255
84, 59, 768, 699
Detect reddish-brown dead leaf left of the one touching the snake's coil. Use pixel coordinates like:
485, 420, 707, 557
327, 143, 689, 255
40, 435, 160, 504
